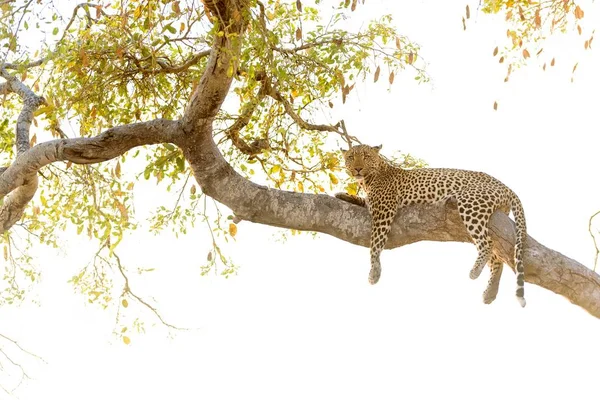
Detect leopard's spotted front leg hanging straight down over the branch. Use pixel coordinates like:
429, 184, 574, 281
369, 203, 397, 285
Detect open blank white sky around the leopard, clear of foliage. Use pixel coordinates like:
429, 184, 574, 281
0, 0, 600, 400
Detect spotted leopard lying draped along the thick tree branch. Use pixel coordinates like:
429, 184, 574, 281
335, 144, 527, 307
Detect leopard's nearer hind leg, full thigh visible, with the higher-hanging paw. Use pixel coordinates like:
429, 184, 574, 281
457, 199, 492, 279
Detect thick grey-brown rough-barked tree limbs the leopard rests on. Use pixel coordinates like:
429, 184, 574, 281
0, 0, 600, 318
